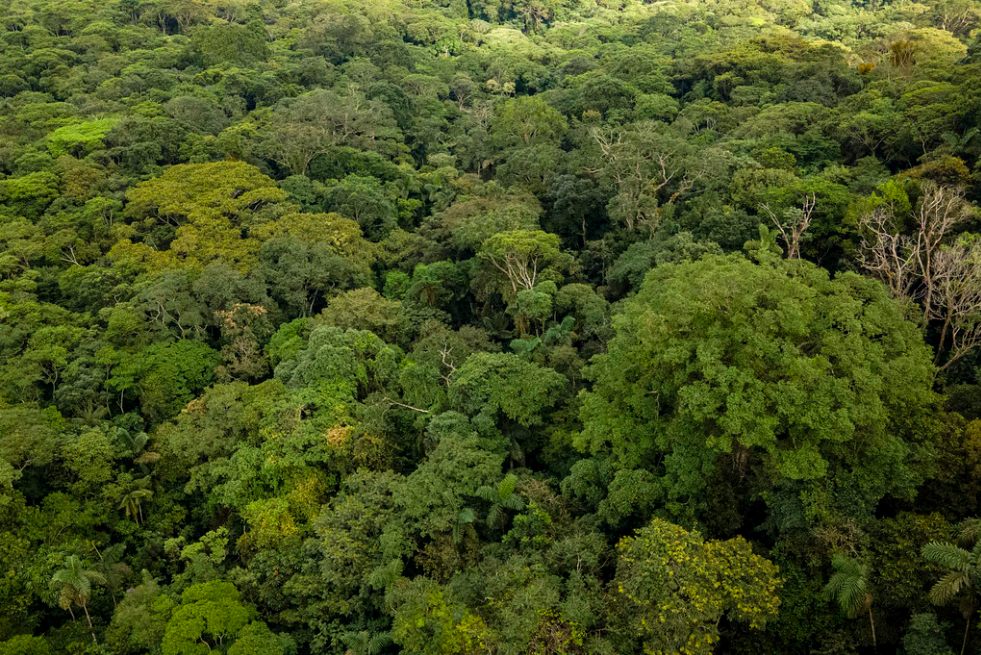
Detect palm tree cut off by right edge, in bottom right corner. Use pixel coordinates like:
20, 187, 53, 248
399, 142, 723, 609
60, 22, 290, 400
923, 519, 981, 655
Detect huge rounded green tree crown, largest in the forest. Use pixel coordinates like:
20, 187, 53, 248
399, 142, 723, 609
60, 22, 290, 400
578, 255, 935, 520
